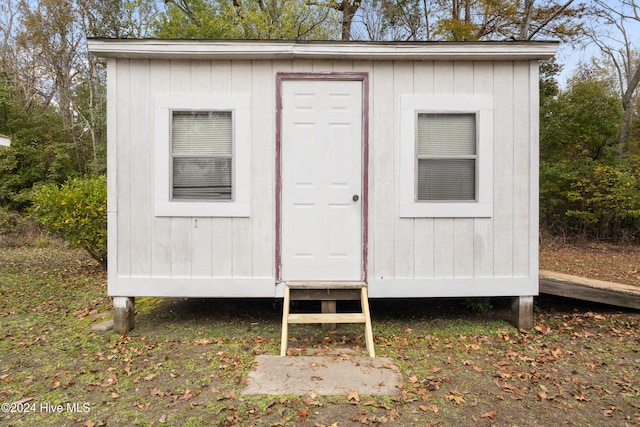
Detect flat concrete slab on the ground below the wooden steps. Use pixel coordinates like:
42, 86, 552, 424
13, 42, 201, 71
242, 354, 402, 396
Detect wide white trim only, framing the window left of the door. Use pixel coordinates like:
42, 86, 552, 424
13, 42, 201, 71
153, 94, 251, 217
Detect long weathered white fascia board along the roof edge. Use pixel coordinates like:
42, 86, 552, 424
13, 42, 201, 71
89, 39, 558, 61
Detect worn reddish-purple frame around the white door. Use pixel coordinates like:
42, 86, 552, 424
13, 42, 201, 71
275, 72, 369, 282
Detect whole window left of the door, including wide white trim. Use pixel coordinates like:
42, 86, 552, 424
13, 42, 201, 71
154, 94, 251, 217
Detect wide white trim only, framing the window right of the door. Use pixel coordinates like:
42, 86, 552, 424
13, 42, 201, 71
398, 95, 493, 218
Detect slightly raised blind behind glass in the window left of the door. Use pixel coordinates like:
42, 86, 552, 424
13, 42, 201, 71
171, 111, 233, 200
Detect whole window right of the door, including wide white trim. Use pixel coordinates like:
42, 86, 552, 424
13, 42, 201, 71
399, 95, 493, 218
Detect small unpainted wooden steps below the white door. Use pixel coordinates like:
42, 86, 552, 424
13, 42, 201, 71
280, 282, 375, 357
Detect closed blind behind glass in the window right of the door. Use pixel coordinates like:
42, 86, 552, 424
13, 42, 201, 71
416, 113, 477, 201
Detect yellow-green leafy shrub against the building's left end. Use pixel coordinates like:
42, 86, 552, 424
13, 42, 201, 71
30, 175, 107, 269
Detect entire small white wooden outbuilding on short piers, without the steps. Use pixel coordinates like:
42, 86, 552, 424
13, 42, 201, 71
89, 39, 557, 332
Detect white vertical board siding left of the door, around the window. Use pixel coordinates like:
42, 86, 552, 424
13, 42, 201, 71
115, 60, 275, 278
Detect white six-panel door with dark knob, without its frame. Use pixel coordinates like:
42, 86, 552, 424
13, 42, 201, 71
281, 80, 363, 281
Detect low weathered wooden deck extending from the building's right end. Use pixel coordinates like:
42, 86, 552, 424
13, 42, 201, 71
539, 270, 640, 310
